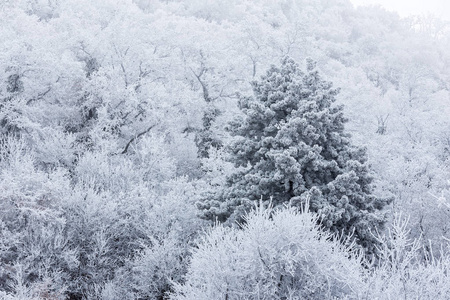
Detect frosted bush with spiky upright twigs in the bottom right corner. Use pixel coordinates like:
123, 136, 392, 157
365, 215, 450, 299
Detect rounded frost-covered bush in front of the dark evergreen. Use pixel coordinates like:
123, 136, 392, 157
172, 203, 364, 300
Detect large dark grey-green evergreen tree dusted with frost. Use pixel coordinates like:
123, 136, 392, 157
200, 58, 391, 253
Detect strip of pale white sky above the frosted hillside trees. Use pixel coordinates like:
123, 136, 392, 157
351, 0, 450, 21
